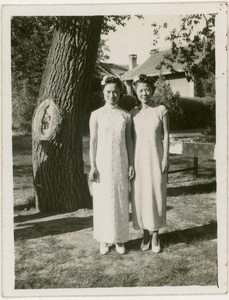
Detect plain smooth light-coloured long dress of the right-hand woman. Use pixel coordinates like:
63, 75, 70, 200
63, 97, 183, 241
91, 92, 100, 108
131, 105, 167, 231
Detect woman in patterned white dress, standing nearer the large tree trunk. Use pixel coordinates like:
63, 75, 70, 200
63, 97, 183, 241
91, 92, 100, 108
89, 77, 134, 254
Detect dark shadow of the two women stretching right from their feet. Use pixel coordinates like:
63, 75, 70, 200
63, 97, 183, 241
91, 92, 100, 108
126, 221, 217, 251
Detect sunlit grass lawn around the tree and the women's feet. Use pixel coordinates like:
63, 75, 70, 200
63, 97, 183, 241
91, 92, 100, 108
13, 136, 217, 289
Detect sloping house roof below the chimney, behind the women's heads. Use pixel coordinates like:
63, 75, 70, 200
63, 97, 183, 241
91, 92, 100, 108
121, 50, 184, 80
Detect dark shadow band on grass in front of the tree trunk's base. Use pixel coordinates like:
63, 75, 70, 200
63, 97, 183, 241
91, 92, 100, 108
14, 214, 93, 239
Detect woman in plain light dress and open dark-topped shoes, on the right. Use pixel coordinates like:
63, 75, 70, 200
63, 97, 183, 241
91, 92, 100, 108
131, 74, 169, 253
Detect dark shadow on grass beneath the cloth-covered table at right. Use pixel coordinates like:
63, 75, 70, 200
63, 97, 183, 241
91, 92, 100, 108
167, 181, 216, 197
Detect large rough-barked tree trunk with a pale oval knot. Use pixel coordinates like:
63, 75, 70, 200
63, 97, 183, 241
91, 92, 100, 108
33, 16, 103, 212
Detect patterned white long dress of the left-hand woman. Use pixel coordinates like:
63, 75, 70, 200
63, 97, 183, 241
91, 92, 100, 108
91, 104, 131, 244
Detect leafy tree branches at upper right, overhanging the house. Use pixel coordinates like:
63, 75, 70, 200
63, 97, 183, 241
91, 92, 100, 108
152, 14, 216, 96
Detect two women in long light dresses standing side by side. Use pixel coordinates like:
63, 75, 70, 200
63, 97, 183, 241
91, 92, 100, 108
89, 75, 169, 254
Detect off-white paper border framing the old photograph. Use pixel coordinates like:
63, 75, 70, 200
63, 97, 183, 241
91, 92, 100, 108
1, 1, 228, 299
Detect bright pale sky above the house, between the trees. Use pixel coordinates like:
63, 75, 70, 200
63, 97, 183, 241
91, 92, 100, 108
102, 15, 184, 65
